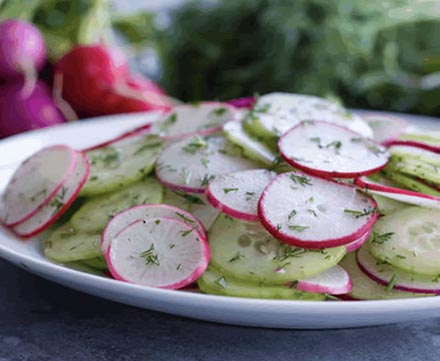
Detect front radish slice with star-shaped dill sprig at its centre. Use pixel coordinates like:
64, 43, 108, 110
106, 218, 210, 289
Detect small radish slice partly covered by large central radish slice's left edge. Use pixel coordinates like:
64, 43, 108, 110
206, 169, 277, 221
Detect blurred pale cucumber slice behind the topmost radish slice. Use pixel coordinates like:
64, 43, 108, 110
246, 93, 373, 139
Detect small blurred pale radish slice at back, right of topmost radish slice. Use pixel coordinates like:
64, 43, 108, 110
362, 113, 408, 144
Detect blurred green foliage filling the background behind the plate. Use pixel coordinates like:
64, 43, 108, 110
0, 0, 440, 116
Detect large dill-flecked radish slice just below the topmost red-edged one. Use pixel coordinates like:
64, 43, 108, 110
258, 172, 378, 249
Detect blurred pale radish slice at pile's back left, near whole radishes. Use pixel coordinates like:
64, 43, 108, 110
151, 102, 239, 140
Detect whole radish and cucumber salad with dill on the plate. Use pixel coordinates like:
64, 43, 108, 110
0, 93, 440, 301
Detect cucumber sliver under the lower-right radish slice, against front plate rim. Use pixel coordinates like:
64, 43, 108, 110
339, 253, 428, 300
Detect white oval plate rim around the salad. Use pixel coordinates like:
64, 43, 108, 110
0, 109, 440, 328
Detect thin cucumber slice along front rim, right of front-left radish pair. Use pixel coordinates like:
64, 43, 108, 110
197, 265, 325, 301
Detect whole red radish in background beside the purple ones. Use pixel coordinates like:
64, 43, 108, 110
55, 44, 171, 116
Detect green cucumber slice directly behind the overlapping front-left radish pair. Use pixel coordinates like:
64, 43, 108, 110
71, 177, 162, 232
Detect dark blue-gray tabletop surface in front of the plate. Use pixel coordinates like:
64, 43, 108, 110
0, 260, 440, 361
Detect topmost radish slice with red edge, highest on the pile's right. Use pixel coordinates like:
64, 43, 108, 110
278, 121, 389, 178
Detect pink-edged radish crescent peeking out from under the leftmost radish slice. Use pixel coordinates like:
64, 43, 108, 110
11, 152, 90, 239
